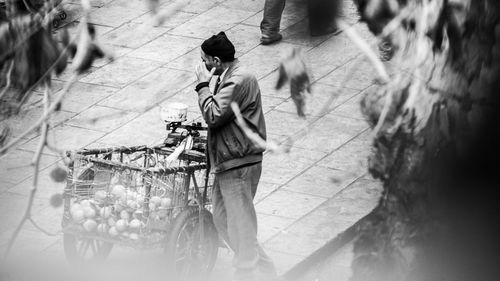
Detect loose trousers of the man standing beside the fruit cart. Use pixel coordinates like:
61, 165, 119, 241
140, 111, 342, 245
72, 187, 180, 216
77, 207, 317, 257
212, 163, 276, 281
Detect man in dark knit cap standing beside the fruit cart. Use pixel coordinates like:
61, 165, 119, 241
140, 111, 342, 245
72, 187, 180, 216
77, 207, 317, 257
195, 32, 276, 280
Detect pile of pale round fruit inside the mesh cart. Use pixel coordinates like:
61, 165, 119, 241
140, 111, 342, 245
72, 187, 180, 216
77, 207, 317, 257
70, 184, 173, 240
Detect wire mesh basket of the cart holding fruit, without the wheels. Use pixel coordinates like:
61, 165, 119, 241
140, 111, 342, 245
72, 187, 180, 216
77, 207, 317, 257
62, 146, 212, 247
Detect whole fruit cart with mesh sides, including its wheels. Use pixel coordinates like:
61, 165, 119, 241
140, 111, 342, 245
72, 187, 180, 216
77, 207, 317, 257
62, 145, 219, 276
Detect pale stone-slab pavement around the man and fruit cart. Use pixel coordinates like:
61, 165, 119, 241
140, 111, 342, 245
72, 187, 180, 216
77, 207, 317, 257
0, 0, 381, 280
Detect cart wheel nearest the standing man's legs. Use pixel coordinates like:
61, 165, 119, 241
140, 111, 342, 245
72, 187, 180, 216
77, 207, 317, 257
165, 207, 219, 280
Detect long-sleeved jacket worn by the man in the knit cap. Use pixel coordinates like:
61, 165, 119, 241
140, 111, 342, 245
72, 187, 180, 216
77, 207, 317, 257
198, 60, 266, 173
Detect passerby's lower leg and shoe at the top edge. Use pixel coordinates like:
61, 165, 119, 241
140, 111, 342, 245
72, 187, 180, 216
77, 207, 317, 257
260, 0, 286, 45
